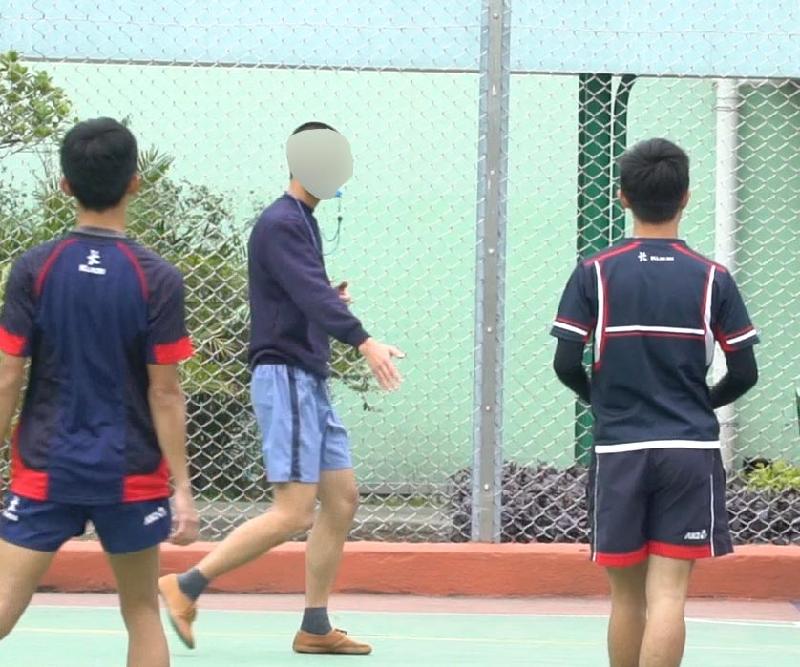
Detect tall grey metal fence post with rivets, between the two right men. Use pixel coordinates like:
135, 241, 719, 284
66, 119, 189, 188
472, 0, 511, 542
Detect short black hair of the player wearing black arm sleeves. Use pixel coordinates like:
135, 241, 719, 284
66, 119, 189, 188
618, 138, 689, 223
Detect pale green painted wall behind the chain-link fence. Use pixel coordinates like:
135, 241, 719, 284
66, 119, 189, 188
7, 64, 800, 483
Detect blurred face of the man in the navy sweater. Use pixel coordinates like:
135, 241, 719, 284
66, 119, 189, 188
286, 130, 353, 199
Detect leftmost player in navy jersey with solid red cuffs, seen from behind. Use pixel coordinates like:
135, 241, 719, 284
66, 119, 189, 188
0, 118, 197, 667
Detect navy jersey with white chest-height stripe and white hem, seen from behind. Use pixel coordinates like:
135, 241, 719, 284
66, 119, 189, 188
551, 239, 758, 452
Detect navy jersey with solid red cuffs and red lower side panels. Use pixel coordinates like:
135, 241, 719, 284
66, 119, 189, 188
0, 230, 192, 505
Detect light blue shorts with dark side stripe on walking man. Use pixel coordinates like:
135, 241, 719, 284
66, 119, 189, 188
250, 365, 353, 484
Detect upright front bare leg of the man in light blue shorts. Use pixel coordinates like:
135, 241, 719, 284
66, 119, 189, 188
306, 470, 358, 607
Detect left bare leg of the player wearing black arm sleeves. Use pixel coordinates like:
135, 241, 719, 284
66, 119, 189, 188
608, 562, 647, 667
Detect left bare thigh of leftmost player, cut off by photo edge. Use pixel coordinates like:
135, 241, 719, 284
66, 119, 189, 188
0, 540, 55, 639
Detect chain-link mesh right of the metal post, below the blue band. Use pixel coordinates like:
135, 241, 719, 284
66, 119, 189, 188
502, 75, 800, 543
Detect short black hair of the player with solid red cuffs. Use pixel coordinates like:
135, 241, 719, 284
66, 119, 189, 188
60, 118, 138, 211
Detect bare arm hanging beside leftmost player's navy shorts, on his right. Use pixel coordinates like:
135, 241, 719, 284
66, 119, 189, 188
147, 364, 198, 545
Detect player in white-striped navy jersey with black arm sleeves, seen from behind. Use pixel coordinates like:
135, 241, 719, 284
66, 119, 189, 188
552, 139, 758, 667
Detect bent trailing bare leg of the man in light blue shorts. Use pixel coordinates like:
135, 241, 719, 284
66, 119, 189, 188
197, 482, 317, 581
